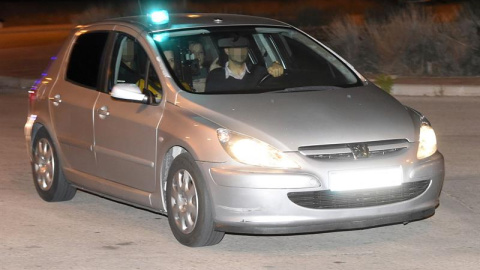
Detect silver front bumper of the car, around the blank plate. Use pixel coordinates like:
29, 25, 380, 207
199, 152, 444, 234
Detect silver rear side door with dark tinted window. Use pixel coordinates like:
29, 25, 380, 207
49, 31, 108, 174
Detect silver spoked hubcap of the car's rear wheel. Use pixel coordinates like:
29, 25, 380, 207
33, 138, 55, 191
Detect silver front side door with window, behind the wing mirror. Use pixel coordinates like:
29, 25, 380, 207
94, 33, 163, 192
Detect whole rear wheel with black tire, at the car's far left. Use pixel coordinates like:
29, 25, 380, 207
32, 128, 77, 202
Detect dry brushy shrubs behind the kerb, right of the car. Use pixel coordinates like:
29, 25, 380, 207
327, 3, 480, 76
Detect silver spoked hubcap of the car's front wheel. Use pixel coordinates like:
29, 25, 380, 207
170, 170, 198, 234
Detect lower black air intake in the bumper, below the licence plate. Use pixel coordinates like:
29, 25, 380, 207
287, 180, 430, 209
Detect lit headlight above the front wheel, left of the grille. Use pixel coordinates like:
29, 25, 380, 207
217, 128, 300, 169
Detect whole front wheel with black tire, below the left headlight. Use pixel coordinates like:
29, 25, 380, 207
166, 153, 225, 247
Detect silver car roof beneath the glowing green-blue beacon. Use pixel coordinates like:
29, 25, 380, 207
96, 13, 291, 32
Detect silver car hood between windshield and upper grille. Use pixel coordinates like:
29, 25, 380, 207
176, 85, 415, 151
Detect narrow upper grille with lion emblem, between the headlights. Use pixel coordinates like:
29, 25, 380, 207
298, 139, 410, 160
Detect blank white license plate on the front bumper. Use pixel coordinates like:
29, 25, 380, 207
328, 166, 403, 191
